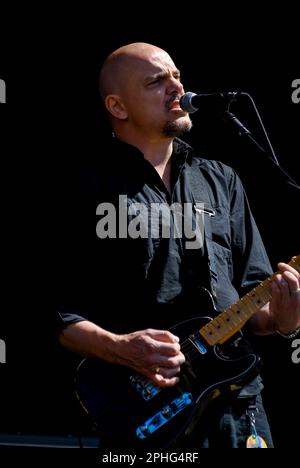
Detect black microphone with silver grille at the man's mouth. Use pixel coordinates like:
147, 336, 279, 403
179, 91, 242, 114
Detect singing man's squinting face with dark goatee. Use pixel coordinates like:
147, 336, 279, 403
118, 50, 191, 137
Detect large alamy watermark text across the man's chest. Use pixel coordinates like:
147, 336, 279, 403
96, 195, 206, 249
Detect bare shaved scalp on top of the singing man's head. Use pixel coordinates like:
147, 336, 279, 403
99, 42, 171, 100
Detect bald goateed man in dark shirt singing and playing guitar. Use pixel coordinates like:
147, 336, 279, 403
59, 43, 300, 448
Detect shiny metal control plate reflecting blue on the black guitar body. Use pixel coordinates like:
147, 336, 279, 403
136, 392, 193, 439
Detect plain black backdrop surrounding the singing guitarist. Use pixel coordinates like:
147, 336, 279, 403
0, 7, 300, 447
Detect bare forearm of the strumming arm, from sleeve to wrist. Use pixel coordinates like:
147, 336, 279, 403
59, 321, 120, 363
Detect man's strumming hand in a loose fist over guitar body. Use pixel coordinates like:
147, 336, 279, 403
116, 328, 185, 387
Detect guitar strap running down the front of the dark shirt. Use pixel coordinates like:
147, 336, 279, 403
187, 158, 218, 298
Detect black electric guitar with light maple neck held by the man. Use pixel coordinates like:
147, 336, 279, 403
75, 255, 300, 450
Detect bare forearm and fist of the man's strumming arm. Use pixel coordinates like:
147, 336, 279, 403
59, 321, 185, 386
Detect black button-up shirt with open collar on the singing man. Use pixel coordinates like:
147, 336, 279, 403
57, 138, 272, 332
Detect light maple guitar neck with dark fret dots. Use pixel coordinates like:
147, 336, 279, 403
199, 255, 300, 346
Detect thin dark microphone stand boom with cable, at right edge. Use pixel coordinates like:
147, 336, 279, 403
223, 92, 300, 190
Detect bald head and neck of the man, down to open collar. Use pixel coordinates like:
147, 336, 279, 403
100, 43, 192, 191
